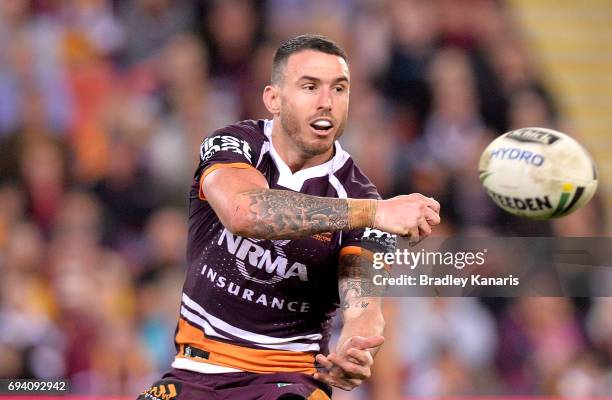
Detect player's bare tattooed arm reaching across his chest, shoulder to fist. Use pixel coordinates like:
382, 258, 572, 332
202, 168, 440, 241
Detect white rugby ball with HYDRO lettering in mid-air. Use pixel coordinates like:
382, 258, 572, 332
479, 128, 597, 219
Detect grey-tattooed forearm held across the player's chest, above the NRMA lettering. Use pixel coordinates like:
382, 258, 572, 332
243, 189, 348, 239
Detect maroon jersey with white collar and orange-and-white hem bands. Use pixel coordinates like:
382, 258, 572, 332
173, 120, 395, 374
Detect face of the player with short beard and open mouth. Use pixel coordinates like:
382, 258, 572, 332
280, 50, 349, 157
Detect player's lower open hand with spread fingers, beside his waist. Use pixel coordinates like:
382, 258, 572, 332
314, 335, 385, 390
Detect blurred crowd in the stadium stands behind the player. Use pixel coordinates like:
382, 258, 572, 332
0, 0, 612, 399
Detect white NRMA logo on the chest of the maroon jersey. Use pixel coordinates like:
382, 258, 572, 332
217, 229, 308, 285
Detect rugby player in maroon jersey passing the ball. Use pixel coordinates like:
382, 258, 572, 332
140, 35, 440, 400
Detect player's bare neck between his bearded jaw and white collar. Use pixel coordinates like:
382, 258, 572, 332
272, 118, 335, 173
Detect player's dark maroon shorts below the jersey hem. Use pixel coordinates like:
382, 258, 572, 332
138, 368, 332, 400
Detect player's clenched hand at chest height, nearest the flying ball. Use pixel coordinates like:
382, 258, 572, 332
374, 193, 440, 245
